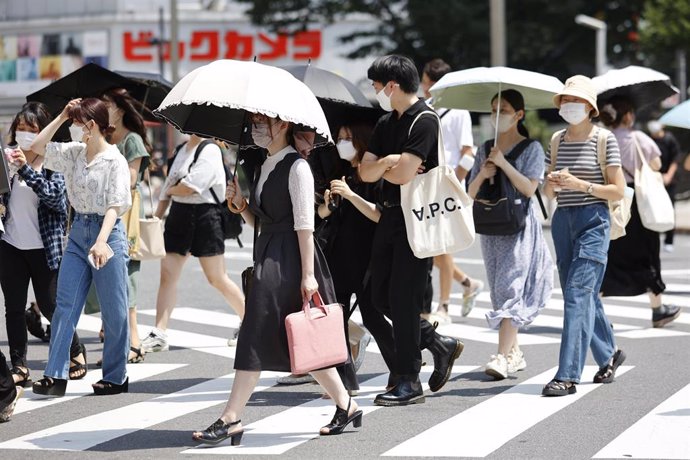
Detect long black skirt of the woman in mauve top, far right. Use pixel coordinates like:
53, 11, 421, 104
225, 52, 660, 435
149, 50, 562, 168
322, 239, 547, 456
601, 190, 666, 297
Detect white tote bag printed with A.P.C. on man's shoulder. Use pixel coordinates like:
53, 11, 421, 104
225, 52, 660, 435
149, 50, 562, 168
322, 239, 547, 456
400, 110, 475, 259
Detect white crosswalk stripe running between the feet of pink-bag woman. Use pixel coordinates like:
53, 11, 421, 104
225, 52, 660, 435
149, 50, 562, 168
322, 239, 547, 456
181, 366, 476, 456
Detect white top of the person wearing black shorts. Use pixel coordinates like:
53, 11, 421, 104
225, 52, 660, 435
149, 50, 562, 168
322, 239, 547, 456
159, 144, 225, 204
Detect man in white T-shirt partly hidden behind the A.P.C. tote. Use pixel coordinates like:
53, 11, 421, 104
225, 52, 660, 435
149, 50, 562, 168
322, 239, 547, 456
422, 59, 484, 322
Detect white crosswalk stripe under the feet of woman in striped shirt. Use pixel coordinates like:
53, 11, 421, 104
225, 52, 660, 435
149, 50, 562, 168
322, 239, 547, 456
383, 366, 632, 457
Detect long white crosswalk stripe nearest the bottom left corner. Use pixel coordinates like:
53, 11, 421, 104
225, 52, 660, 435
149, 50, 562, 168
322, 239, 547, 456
0, 372, 284, 451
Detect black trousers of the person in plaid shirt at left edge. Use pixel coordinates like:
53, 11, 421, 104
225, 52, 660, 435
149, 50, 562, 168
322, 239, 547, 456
0, 241, 81, 367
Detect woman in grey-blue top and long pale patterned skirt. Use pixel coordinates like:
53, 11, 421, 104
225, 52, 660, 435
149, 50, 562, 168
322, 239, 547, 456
469, 90, 553, 380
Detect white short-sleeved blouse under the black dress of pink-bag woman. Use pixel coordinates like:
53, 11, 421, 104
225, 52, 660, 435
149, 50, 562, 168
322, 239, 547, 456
255, 146, 314, 231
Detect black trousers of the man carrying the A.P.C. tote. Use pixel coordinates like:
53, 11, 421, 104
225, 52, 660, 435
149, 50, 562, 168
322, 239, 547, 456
371, 207, 436, 380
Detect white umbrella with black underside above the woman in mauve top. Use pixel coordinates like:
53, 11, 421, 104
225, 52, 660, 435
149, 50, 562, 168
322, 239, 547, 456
592, 65, 678, 109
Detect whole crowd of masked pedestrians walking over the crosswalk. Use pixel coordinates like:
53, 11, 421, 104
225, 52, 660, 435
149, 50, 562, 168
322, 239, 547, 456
0, 55, 680, 445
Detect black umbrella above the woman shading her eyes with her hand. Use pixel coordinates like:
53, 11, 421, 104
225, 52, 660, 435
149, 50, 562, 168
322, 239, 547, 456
26, 63, 145, 115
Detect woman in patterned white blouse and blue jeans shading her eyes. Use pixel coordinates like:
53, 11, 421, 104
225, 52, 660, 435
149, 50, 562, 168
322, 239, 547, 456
31, 98, 132, 396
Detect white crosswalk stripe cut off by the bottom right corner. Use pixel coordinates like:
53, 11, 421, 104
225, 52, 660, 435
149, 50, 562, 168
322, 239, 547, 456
593, 385, 690, 459
